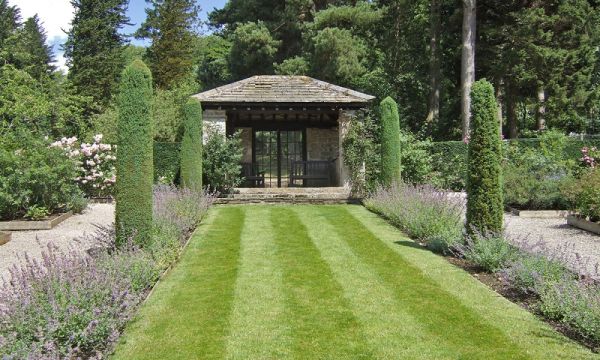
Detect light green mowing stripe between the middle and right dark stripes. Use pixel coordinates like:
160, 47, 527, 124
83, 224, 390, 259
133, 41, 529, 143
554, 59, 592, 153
295, 207, 460, 359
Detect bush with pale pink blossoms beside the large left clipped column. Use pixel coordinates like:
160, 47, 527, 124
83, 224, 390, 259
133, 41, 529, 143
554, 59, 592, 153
50, 134, 117, 197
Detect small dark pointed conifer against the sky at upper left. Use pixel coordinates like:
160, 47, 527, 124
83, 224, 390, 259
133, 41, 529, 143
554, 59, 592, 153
19, 14, 55, 80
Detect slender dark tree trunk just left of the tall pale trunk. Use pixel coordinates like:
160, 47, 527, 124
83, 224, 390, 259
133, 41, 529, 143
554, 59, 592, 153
425, 0, 441, 128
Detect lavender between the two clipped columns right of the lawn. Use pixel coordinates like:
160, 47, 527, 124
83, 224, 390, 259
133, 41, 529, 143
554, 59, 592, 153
365, 183, 464, 253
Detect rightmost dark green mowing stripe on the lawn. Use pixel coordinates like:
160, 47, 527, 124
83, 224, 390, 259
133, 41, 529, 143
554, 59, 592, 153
318, 206, 529, 359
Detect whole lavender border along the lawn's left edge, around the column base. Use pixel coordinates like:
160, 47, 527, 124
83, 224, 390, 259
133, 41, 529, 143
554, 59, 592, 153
0, 186, 215, 359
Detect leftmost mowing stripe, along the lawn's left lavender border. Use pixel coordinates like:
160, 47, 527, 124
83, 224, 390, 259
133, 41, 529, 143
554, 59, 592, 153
115, 207, 244, 360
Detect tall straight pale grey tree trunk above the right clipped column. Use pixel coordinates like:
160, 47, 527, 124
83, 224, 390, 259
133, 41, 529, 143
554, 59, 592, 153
461, 0, 477, 138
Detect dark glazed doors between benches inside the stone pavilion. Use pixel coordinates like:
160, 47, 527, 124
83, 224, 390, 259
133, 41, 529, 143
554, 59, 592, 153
252, 130, 306, 187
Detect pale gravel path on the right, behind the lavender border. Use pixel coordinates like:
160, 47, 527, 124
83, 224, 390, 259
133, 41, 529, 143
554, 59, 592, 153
505, 214, 600, 273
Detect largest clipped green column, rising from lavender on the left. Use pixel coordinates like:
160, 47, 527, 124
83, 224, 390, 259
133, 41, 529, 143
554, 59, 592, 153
115, 60, 153, 246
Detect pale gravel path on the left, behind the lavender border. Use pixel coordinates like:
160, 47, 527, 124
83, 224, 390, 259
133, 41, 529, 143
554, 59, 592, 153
0, 204, 115, 278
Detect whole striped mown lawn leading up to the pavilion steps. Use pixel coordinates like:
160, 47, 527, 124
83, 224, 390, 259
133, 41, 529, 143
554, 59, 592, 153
114, 205, 597, 359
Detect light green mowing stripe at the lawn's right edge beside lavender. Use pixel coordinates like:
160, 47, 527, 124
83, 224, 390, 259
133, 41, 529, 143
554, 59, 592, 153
346, 206, 599, 360
